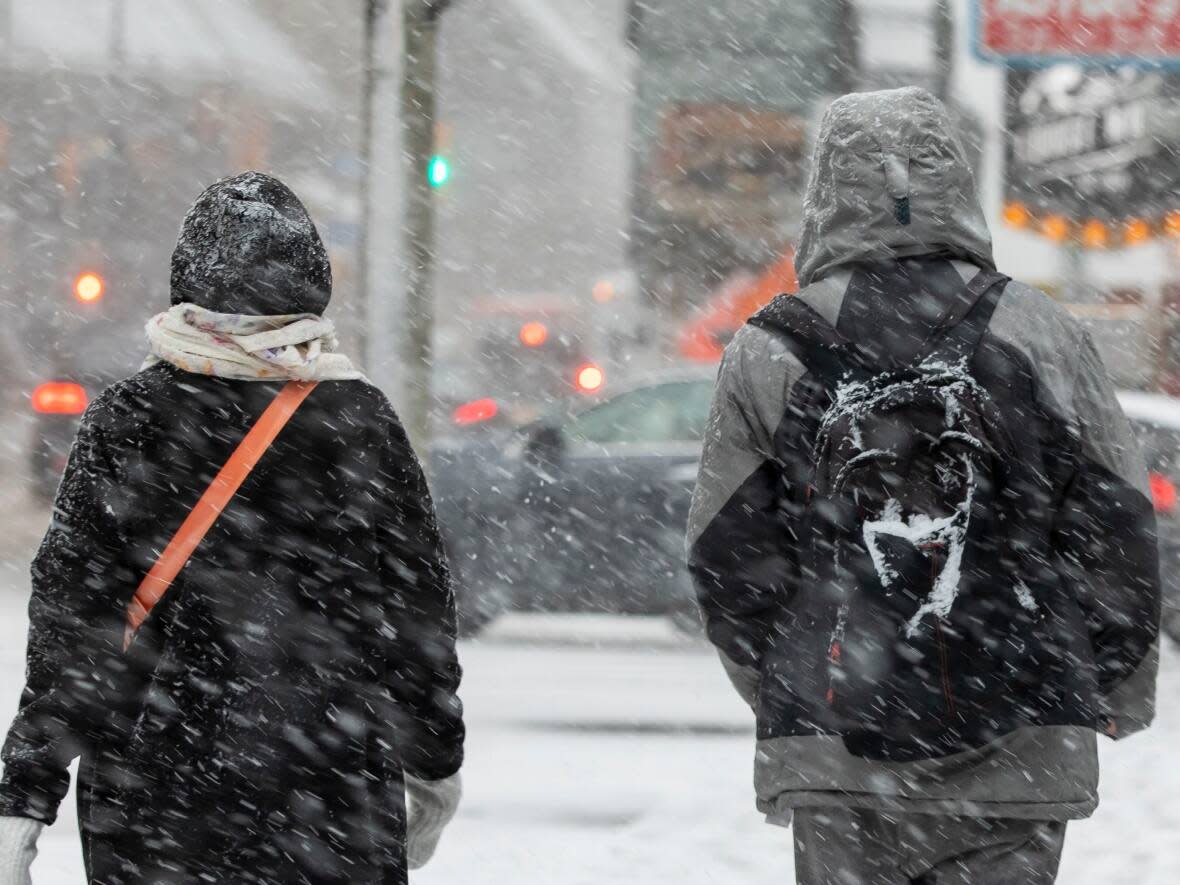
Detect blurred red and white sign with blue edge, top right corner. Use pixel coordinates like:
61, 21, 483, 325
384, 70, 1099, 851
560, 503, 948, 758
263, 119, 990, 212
975, 0, 1180, 63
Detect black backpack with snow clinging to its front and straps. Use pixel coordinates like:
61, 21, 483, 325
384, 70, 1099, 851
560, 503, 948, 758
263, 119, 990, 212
752, 271, 1057, 761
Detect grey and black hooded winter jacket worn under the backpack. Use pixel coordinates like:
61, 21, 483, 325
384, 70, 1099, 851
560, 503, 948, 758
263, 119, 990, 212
688, 89, 1159, 822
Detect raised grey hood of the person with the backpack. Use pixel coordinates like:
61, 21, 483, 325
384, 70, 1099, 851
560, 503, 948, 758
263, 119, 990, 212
795, 86, 995, 286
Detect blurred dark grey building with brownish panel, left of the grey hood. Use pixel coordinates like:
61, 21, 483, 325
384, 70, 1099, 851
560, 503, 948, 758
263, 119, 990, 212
628, 0, 840, 311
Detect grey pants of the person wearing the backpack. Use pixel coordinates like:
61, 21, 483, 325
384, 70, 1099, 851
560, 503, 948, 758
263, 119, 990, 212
793, 808, 1066, 885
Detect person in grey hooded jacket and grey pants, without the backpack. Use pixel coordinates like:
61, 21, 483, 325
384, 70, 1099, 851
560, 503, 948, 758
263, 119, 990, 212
688, 89, 1160, 885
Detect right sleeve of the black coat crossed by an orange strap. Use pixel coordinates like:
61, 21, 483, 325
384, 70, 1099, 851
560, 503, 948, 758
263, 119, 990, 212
376, 406, 464, 780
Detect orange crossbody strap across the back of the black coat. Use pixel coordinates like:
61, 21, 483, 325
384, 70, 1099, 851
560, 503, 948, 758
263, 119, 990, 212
123, 381, 316, 651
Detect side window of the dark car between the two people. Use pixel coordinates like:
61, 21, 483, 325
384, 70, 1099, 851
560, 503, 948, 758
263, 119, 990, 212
565, 381, 713, 445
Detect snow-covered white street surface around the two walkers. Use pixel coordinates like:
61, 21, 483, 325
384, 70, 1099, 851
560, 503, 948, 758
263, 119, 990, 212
0, 571, 1180, 885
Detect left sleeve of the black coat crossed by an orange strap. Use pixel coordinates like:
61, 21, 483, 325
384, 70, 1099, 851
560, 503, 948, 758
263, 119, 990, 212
0, 400, 125, 822
